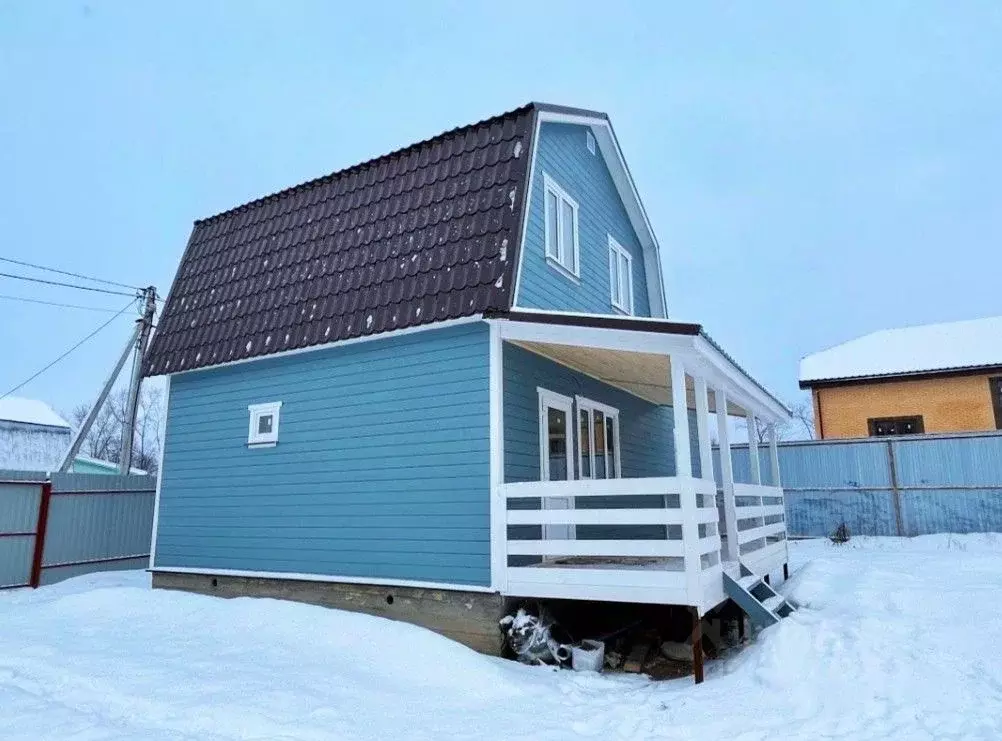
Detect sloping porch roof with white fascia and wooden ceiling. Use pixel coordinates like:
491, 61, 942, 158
485, 309, 790, 422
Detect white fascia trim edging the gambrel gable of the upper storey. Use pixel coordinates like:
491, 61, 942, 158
513, 110, 667, 318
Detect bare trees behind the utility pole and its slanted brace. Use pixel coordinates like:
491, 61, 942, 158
70, 386, 163, 475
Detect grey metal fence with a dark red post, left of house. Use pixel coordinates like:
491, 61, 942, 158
0, 471, 156, 589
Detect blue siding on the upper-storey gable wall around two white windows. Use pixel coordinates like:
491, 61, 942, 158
518, 123, 650, 316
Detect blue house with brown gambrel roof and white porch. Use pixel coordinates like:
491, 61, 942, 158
144, 103, 789, 651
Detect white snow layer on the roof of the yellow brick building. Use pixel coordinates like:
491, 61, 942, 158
801, 316, 1002, 384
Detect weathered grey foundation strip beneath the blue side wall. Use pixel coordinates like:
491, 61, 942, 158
153, 572, 505, 656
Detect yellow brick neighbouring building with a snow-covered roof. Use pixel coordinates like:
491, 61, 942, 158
801, 316, 1002, 440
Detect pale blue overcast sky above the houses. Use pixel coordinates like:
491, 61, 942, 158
0, 0, 1002, 420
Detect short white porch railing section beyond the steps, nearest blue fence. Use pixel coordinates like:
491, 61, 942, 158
734, 484, 789, 574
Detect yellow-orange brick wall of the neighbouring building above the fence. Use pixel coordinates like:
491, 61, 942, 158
812, 375, 997, 439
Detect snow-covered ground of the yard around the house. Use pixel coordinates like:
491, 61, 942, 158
0, 536, 1002, 741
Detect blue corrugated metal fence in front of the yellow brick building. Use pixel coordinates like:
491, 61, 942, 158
714, 433, 1002, 537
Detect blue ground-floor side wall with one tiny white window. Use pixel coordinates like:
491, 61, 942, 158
155, 323, 490, 585
